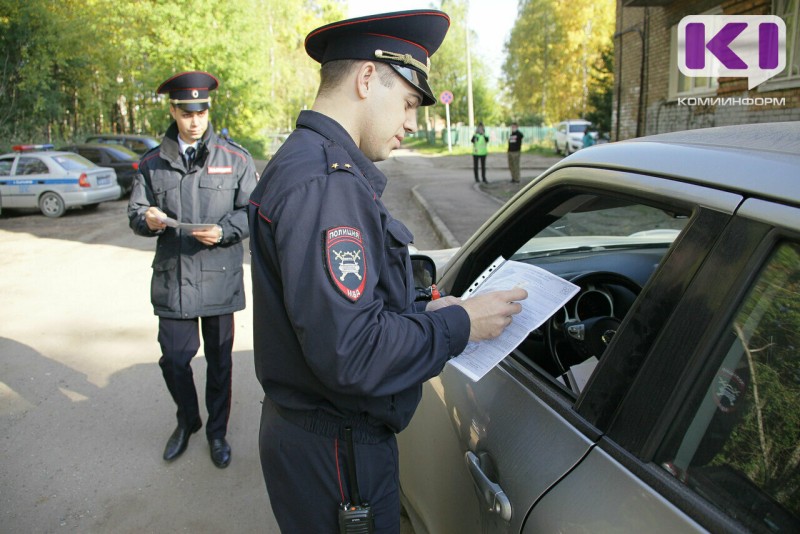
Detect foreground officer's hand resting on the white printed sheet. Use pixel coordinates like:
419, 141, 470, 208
460, 287, 528, 341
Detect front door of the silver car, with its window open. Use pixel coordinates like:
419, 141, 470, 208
399, 167, 741, 532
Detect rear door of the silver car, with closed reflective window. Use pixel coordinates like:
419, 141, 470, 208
530, 198, 800, 532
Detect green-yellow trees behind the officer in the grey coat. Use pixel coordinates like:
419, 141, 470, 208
0, 0, 346, 157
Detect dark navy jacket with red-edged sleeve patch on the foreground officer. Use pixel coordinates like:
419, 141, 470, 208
250, 111, 470, 442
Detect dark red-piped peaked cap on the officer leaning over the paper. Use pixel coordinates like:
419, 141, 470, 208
305, 9, 450, 106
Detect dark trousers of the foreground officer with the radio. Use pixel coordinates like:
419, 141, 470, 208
259, 398, 400, 534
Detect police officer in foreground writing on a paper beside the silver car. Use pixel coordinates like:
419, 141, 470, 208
249, 10, 527, 533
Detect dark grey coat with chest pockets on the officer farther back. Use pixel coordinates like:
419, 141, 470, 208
128, 122, 257, 319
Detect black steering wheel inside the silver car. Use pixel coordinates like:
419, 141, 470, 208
544, 271, 642, 373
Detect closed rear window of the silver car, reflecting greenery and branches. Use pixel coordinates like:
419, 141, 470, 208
656, 243, 800, 532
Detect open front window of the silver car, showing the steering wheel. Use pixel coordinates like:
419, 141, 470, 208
510, 193, 691, 397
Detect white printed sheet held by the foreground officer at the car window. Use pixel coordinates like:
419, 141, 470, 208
448, 258, 580, 382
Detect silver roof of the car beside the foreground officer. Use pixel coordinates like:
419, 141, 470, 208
549, 121, 800, 204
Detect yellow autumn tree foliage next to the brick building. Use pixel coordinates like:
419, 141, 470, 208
503, 0, 615, 124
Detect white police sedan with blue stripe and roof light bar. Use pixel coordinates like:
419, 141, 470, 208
0, 145, 121, 217
